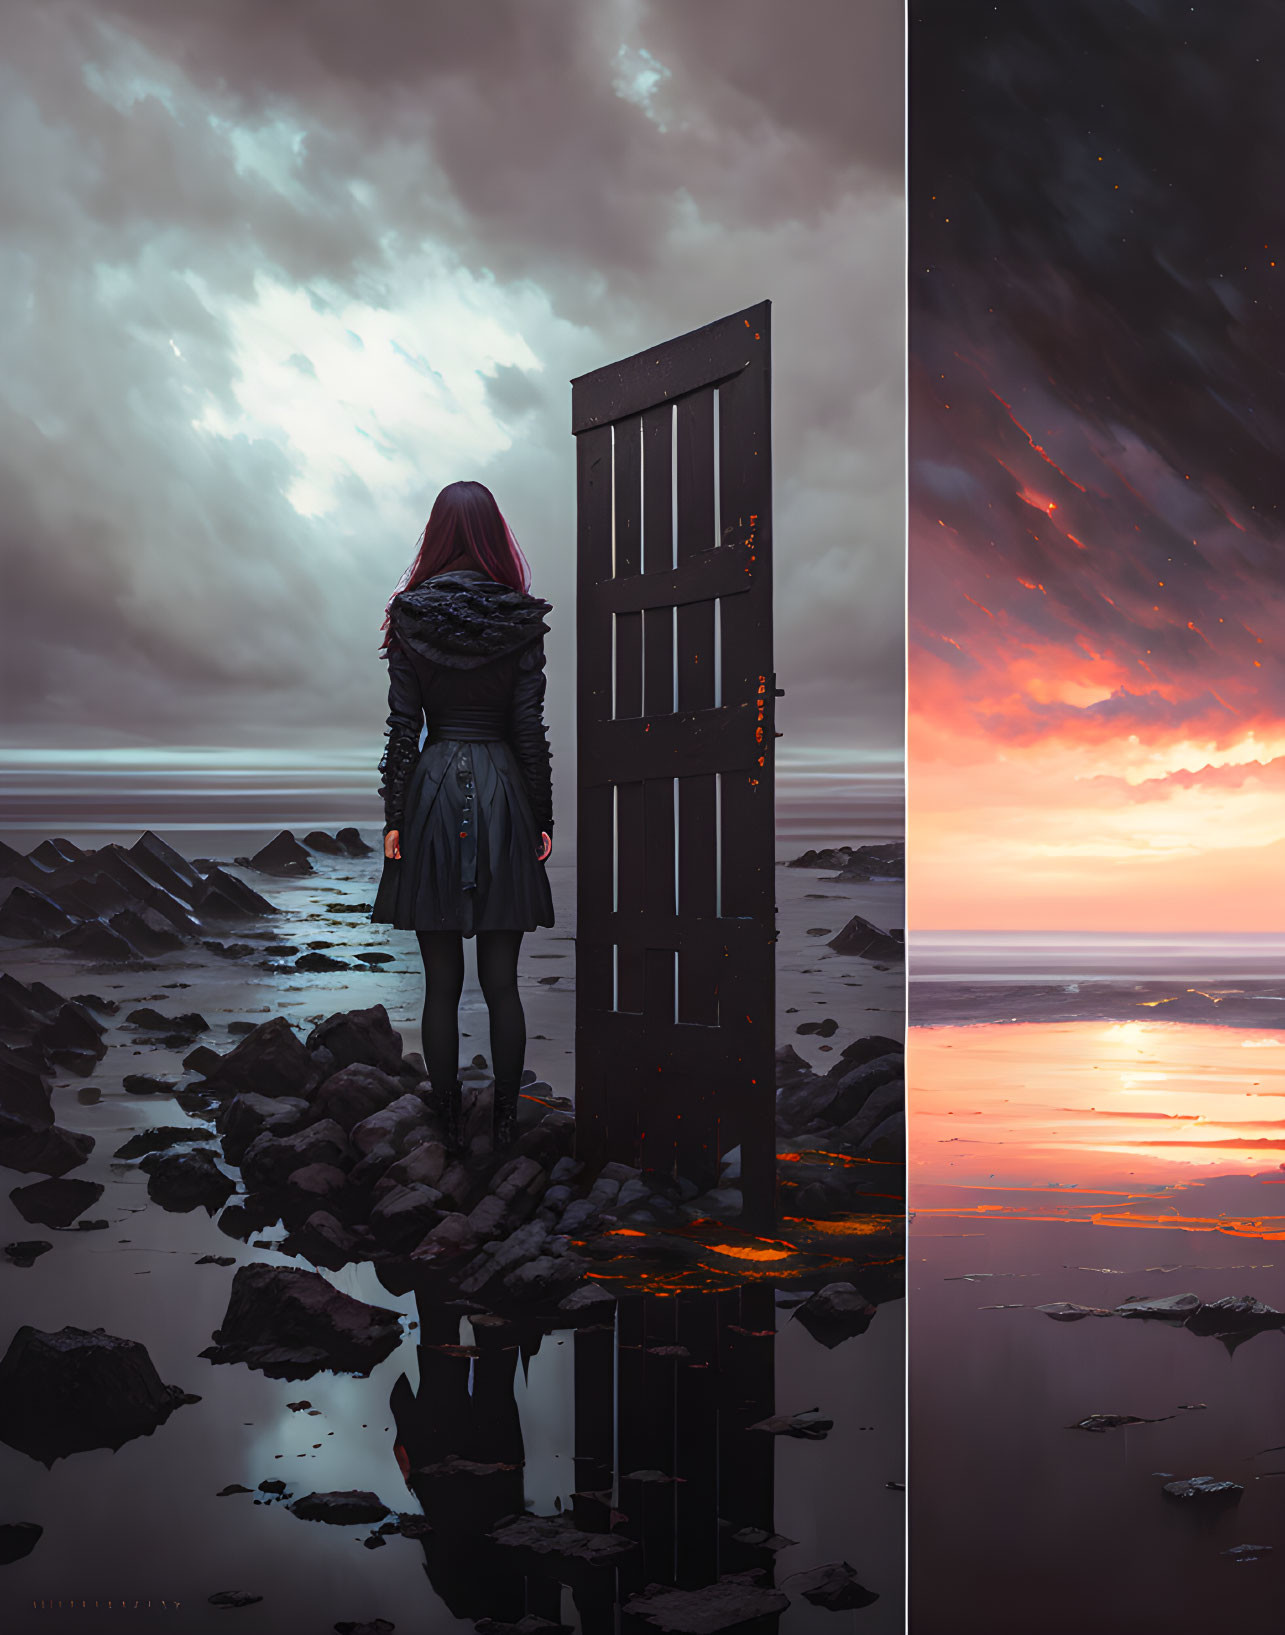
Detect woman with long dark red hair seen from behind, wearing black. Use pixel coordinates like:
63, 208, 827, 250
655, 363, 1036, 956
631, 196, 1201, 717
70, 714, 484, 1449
371, 482, 554, 1148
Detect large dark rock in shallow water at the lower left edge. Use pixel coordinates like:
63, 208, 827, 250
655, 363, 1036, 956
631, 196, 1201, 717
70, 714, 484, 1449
0, 1324, 198, 1465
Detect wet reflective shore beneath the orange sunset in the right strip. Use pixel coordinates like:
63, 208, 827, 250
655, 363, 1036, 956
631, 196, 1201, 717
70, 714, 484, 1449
909, 978, 1285, 1635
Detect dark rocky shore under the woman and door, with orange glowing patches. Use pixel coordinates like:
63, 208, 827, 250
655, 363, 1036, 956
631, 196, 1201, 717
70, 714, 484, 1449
0, 831, 906, 1311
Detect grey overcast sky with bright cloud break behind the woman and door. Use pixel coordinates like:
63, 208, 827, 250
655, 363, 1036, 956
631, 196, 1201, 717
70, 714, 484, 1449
0, 0, 904, 810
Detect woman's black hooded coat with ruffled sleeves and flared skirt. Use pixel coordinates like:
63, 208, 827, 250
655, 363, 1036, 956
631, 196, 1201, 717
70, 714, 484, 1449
371, 569, 554, 935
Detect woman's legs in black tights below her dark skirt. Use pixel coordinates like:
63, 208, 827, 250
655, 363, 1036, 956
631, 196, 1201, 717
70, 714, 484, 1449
415, 930, 526, 1091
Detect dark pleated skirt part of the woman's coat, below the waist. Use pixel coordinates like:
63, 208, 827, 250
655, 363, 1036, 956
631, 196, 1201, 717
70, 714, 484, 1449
371, 737, 554, 937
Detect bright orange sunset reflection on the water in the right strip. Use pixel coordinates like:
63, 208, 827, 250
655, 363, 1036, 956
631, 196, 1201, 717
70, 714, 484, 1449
911, 1020, 1285, 1192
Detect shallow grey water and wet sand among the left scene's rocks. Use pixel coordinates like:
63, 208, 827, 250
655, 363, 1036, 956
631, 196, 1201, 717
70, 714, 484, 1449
0, 829, 904, 1635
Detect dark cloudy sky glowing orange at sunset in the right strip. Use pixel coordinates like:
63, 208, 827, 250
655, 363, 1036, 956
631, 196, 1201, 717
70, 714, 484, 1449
909, 0, 1285, 932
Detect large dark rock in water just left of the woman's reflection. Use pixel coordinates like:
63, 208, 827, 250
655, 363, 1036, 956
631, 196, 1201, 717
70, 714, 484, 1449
201, 1261, 401, 1380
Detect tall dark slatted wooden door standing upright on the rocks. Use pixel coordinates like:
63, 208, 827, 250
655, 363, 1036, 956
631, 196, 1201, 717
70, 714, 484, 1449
572, 301, 777, 1221
